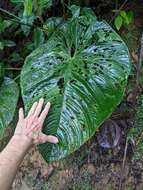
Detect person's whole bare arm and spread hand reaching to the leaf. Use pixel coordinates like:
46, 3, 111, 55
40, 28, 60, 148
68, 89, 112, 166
0, 99, 58, 190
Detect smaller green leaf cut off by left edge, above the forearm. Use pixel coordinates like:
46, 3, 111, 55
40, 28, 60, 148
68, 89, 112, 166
0, 77, 19, 137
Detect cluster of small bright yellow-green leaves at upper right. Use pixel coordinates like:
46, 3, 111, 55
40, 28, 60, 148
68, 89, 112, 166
114, 11, 134, 30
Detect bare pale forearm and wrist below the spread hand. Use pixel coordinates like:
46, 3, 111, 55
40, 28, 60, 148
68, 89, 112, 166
0, 135, 31, 190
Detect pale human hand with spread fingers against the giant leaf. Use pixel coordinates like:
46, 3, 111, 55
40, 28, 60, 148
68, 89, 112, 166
14, 98, 58, 144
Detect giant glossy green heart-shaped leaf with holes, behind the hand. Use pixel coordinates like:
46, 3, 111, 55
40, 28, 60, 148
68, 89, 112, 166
21, 9, 130, 161
